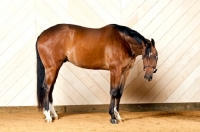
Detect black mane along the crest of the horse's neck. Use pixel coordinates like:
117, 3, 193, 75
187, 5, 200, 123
112, 24, 147, 45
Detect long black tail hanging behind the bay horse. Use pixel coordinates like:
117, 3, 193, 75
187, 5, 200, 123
36, 37, 45, 110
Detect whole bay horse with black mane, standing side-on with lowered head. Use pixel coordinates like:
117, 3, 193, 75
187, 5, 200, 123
36, 24, 158, 124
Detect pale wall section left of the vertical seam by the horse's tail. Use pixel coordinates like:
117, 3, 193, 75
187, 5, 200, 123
0, 0, 36, 106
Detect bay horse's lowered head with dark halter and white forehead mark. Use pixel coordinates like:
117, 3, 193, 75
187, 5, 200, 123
142, 39, 158, 81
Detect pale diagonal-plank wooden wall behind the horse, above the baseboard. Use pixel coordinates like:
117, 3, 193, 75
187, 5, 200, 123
0, 0, 200, 106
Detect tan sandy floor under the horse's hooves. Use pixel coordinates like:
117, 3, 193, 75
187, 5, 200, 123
0, 111, 200, 132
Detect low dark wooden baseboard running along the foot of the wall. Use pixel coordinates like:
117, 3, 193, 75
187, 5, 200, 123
0, 102, 200, 113
